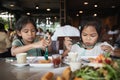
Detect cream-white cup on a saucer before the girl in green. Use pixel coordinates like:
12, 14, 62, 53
16, 53, 27, 64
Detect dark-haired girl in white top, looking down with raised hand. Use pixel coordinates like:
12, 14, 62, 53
63, 18, 113, 56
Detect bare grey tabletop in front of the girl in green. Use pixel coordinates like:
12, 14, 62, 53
0, 57, 68, 80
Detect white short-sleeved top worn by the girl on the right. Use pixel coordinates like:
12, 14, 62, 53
71, 42, 113, 57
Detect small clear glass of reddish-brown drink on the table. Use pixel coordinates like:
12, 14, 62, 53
52, 54, 61, 68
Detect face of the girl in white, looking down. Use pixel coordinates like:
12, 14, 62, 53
81, 26, 98, 46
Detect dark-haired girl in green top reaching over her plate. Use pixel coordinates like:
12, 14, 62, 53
11, 16, 51, 56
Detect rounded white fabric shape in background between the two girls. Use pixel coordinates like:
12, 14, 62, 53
51, 25, 80, 41
